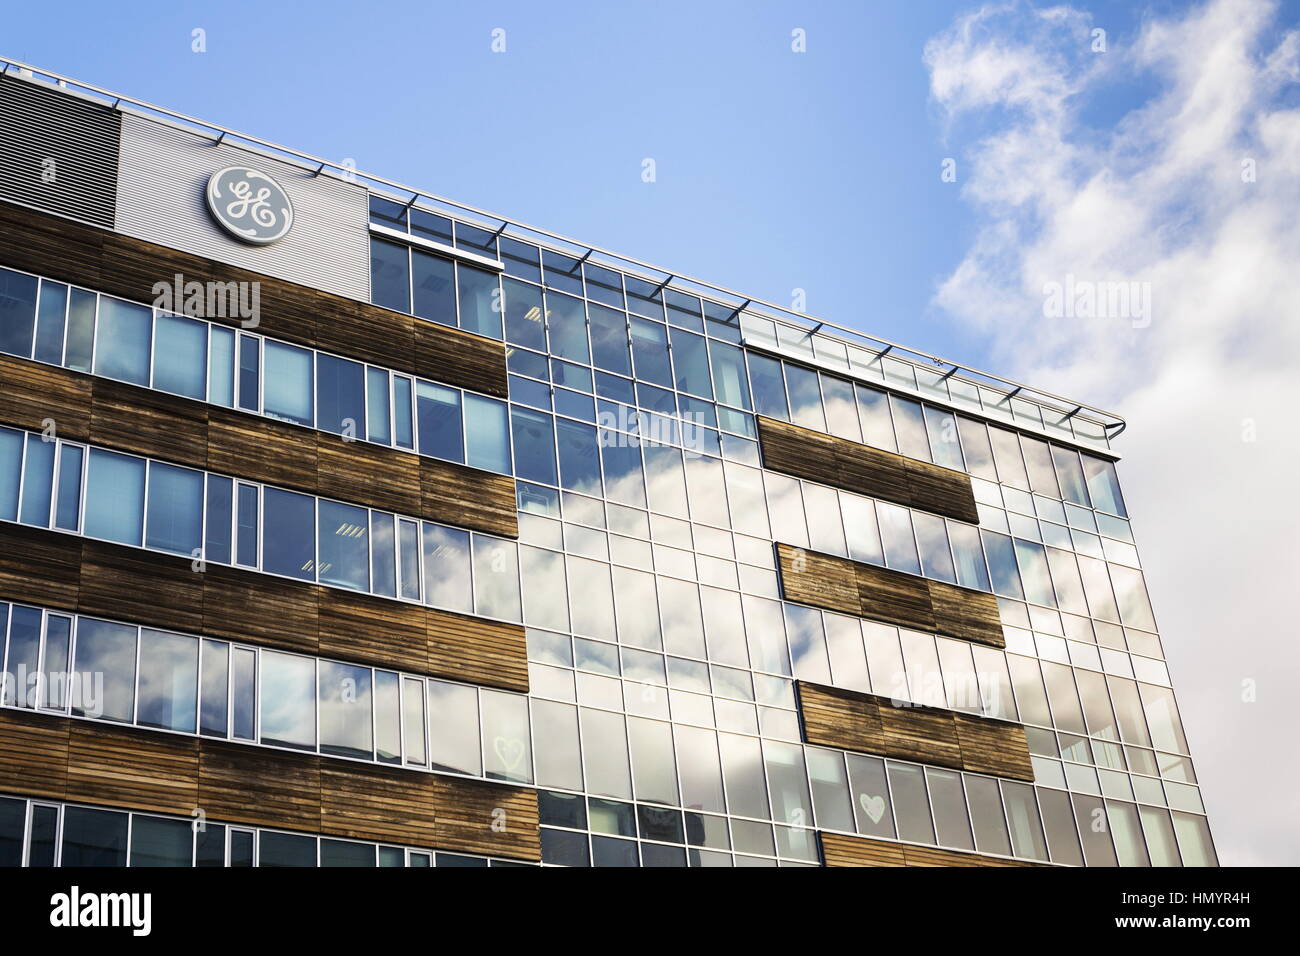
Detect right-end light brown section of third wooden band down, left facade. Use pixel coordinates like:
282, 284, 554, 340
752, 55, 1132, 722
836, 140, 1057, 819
425, 609, 528, 692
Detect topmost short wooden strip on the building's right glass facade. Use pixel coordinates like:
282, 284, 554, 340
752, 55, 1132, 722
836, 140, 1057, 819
758, 416, 979, 523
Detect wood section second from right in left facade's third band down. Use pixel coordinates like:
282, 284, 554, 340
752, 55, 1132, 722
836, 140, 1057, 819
317, 588, 429, 674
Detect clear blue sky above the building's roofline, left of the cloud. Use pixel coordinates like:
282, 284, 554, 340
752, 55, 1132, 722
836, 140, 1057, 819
0, 0, 1185, 369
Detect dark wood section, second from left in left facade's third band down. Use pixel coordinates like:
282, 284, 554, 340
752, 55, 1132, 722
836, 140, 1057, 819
74, 538, 204, 632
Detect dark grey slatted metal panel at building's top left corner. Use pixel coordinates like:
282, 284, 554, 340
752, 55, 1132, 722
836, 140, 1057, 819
0, 74, 121, 229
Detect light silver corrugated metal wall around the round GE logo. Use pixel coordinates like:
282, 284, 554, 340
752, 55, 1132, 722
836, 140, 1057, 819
117, 113, 371, 302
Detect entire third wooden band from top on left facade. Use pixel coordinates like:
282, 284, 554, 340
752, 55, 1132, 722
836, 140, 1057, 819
0, 523, 528, 693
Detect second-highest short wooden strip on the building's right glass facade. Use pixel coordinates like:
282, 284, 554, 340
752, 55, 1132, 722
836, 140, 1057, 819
776, 544, 1006, 648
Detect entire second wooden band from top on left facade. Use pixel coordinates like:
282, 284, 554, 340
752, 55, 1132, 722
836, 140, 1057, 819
0, 345, 519, 537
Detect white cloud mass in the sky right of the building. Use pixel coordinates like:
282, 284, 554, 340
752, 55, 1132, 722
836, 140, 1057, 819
924, 0, 1300, 864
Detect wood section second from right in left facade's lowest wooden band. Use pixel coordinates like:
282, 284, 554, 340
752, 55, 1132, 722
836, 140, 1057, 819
321, 761, 438, 847
